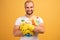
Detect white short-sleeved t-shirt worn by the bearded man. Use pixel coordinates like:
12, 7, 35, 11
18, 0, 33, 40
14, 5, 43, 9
15, 16, 43, 40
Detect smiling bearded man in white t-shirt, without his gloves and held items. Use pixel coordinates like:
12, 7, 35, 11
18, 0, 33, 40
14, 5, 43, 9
13, 1, 44, 40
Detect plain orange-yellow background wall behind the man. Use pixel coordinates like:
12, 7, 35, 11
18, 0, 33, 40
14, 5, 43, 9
0, 0, 60, 40
